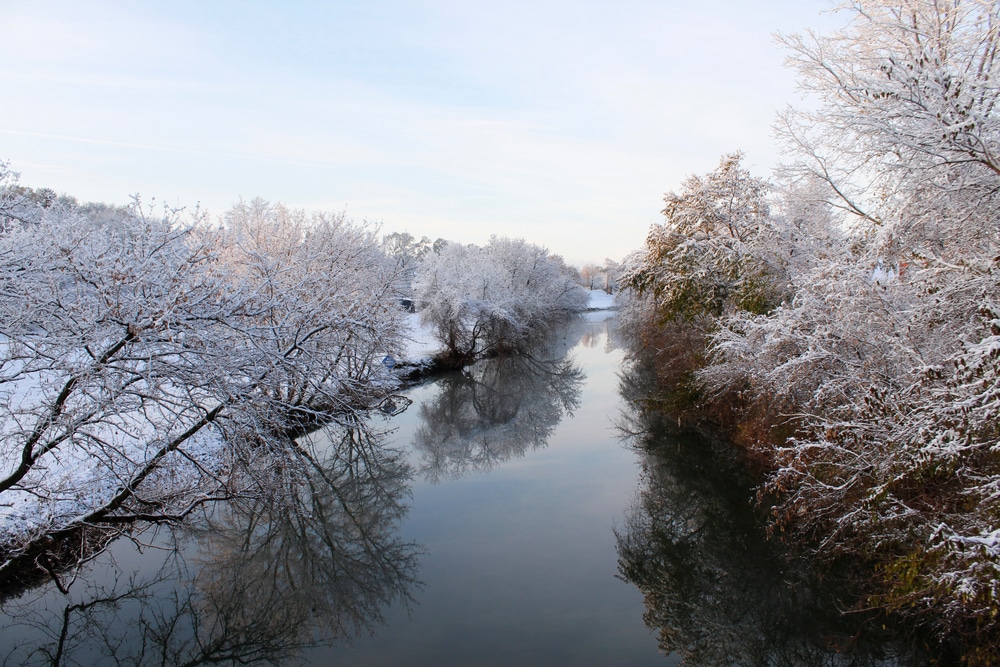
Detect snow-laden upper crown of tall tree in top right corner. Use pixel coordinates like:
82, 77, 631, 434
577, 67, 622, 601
779, 0, 1000, 262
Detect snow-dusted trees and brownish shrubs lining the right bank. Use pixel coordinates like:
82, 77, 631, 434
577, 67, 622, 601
623, 0, 1000, 664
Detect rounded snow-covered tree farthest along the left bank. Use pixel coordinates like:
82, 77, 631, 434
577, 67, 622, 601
414, 237, 587, 361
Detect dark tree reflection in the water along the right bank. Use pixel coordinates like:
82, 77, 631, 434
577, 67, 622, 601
616, 364, 925, 667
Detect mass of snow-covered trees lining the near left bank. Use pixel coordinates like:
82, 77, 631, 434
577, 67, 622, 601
0, 194, 399, 573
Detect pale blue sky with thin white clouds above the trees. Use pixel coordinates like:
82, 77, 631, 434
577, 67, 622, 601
0, 0, 843, 265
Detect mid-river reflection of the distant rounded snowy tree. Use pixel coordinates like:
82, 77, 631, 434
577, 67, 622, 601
413, 340, 585, 482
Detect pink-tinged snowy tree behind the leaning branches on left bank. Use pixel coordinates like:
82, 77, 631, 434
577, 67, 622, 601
222, 200, 402, 413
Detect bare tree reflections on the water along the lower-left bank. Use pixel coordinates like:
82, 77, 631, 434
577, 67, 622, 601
0, 427, 418, 665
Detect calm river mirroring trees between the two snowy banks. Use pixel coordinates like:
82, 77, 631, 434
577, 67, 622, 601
0, 313, 936, 665
